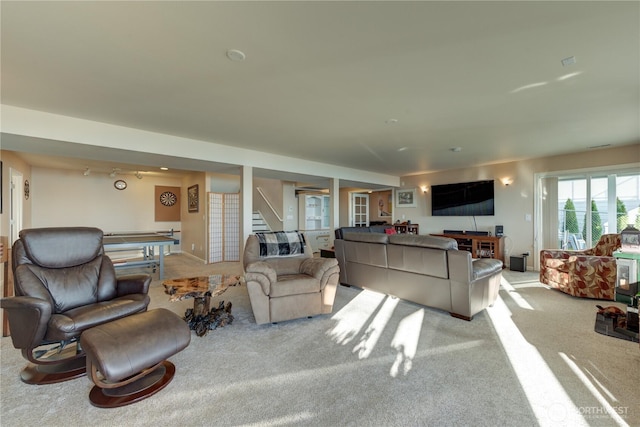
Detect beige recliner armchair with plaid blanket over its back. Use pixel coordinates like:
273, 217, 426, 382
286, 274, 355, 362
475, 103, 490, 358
243, 232, 340, 324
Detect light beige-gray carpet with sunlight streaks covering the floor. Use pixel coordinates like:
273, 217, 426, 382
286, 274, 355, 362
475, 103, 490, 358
0, 255, 640, 426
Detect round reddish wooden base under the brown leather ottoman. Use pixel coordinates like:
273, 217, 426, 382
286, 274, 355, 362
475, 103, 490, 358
89, 360, 176, 408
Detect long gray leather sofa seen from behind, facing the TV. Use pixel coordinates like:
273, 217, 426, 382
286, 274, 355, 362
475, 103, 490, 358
334, 231, 502, 320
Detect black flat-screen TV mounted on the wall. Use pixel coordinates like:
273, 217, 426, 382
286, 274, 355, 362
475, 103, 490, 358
431, 180, 494, 216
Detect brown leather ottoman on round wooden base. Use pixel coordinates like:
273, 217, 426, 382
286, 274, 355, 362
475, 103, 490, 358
80, 308, 191, 408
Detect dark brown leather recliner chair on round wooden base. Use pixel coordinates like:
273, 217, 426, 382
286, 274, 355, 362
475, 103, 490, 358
0, 227, 151, 384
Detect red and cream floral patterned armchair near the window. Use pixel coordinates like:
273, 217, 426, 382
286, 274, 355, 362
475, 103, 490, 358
540, 234, 620, 300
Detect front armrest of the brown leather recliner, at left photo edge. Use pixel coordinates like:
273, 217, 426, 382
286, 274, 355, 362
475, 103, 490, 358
0, 296, 52, 349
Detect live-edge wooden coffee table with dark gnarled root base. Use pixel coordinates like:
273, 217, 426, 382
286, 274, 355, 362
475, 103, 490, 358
162, 274, 242, 336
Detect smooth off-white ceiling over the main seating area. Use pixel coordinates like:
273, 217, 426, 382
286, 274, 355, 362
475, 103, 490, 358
0, 0, 640, 181
